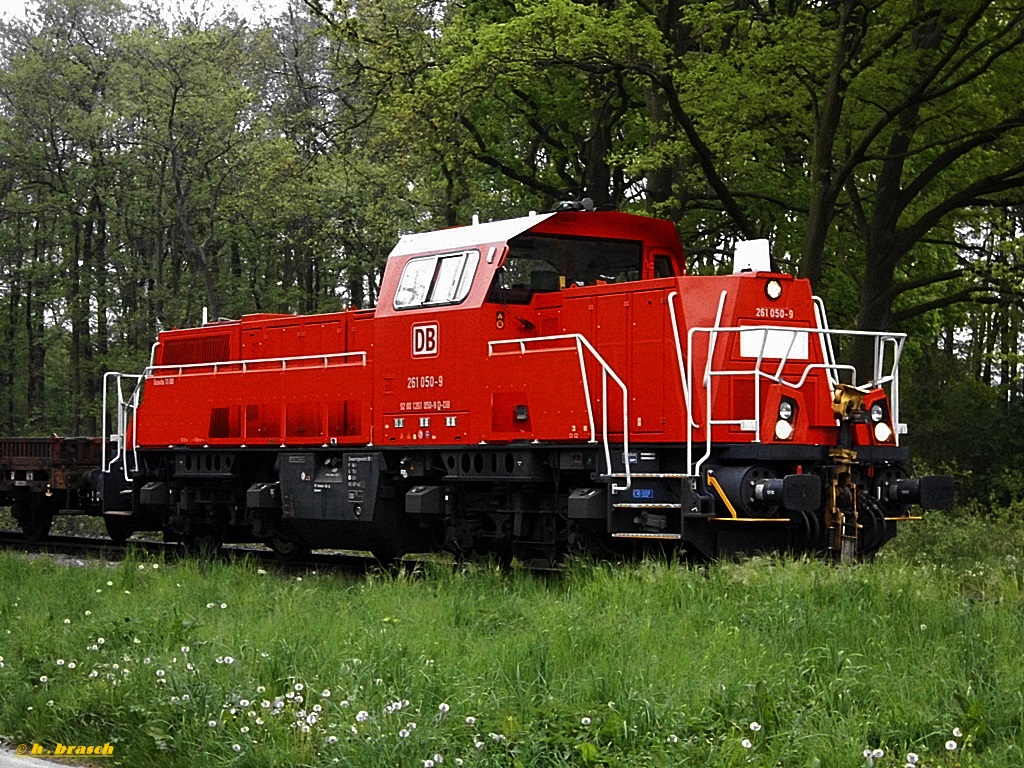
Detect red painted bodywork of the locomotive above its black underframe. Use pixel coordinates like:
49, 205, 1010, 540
135, 212, 897, 456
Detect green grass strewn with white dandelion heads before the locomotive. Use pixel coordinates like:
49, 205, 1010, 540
0, 517, 1024, 768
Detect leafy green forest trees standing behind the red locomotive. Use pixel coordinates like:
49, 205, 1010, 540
0, 0, 1024, 512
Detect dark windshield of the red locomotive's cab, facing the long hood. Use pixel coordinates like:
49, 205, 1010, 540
488, 233, 643, 304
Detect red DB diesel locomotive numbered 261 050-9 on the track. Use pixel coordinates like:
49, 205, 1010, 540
0, 207, 952, 562
